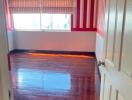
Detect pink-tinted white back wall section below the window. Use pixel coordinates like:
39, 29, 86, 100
14, 31, 96, 52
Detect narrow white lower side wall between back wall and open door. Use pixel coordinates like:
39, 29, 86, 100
96, 34, 104, 61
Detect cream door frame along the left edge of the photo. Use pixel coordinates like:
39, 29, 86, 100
0, 0, 14, 100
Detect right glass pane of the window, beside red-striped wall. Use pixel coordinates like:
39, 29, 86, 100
41, 14, 71, 30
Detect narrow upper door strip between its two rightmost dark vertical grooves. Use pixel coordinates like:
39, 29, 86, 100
114, 0, 125, 69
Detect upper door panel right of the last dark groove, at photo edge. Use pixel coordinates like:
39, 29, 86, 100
121, 0, 132, 77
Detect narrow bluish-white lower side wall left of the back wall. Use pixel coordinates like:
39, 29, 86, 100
7, 32, 14, 51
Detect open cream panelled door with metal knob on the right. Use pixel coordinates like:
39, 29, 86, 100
100, 0, 132, 100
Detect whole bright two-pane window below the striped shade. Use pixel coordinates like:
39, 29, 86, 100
13, 14, 71, 31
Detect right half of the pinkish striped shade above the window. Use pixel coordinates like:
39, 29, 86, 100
42, 0, 74, 13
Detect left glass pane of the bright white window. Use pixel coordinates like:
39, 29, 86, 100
13, 14, 40, 30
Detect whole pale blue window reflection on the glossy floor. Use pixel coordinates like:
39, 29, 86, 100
17, 68, 71, 92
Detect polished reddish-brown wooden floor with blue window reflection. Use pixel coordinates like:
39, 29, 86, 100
11, 53, 98, 100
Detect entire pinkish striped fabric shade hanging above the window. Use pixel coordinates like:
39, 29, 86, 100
9, 0, 76, 13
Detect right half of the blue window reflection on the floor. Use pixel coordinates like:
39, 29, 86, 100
43, 72, 71, 91
